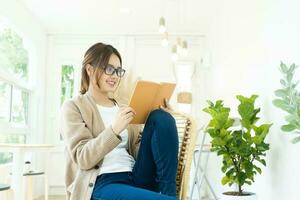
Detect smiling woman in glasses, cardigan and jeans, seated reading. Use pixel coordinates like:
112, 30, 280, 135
60, 43, 178, 200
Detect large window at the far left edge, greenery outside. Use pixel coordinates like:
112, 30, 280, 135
0, 21, 32, 164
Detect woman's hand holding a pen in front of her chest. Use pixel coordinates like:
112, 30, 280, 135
111, 106, 136, 135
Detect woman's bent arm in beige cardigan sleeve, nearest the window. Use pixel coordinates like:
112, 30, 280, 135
60, 101, 121, 170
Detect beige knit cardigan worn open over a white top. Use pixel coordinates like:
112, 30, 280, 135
60, 93, 141, 200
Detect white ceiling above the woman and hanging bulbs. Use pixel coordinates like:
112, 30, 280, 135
19, 0, 212, 34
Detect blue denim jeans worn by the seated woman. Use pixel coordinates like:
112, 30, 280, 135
91, 109, 178, 200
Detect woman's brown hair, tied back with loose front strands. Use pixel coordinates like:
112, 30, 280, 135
80, 42, 122, 94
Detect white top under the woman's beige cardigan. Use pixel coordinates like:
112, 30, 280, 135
97, 105, 135, 175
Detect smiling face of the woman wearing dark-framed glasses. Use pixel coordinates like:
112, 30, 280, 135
93, 54, 121, 93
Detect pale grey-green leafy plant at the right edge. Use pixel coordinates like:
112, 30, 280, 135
273, 62, 300, 143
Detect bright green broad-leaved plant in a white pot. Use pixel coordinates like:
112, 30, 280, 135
203, 95, 272, 200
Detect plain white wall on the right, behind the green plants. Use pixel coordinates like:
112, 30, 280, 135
202, 0, 300, 200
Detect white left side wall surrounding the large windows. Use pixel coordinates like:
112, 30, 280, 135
0, 0, 47, 198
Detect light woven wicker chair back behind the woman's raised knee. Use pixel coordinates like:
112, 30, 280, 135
172, 113, 197, 200
